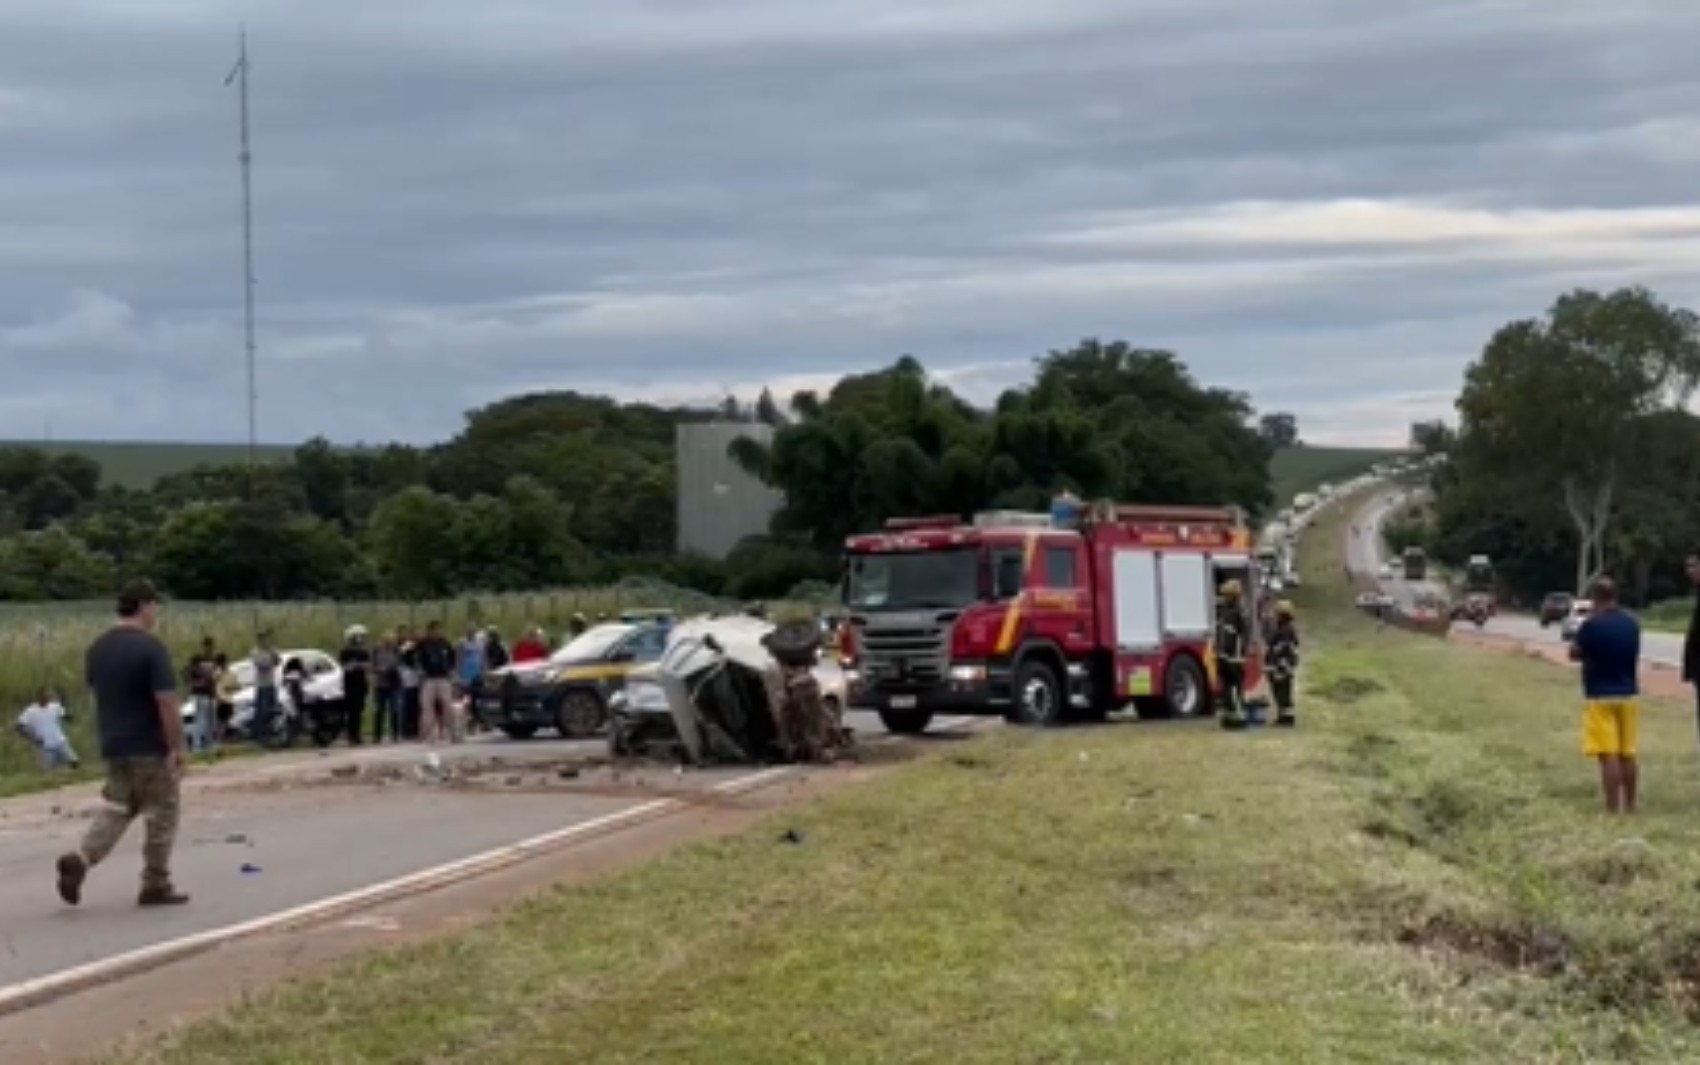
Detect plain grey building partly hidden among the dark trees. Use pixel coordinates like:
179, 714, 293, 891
673, 422, 785, 558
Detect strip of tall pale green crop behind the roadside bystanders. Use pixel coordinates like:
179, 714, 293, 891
0, 580, 737, 796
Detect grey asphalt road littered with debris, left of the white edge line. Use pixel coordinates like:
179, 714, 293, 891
0, 700, 938, 994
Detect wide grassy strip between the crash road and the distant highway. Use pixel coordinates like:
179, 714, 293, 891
96, 486, 1700, 1065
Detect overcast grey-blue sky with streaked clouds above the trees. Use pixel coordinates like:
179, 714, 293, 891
0, 0, 1700, 444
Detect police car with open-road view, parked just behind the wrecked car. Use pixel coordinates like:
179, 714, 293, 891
473, 621, 668, 740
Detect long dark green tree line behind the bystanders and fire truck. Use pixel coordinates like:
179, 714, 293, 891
0, 340, 1297, 601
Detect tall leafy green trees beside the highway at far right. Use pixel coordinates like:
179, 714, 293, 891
1411, 288, 1700, 604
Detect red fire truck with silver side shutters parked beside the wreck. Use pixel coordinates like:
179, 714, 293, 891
840, 504, 1261, 733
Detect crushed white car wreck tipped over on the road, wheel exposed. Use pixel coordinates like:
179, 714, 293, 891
609, 616, 850, 766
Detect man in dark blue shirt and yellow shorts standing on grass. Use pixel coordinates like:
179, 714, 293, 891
1571, 578, 1641, 813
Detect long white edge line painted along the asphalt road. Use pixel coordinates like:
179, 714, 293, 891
0, 718, 983, 1016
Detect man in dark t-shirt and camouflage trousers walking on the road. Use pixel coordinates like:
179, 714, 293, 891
58, 580, 189, 907
